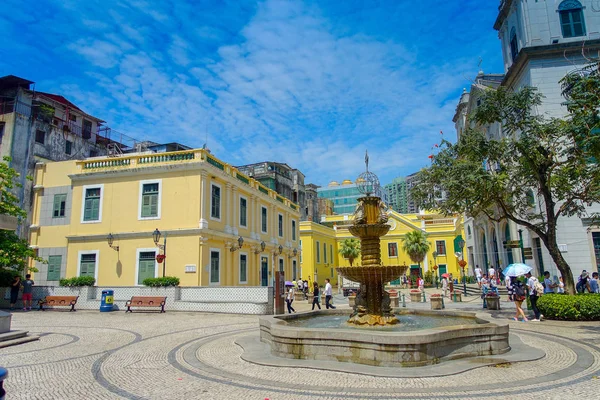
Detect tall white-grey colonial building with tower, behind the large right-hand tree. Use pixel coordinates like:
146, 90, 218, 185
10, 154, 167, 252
453, 0, 600, 277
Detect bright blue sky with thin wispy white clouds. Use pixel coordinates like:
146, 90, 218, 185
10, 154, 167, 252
0, 0, 502, 185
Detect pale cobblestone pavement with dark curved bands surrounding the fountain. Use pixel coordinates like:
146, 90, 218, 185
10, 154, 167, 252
0, 301, 600, 400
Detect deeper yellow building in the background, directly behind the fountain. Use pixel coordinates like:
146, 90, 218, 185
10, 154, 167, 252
300, 211, 464, 284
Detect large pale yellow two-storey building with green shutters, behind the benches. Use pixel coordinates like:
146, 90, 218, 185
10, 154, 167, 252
30, 149, 300, 286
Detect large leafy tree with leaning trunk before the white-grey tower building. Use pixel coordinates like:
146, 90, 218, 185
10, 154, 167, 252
411, 76, 600, 293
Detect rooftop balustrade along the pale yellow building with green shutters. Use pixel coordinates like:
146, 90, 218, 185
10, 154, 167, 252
77, 149, 298, 211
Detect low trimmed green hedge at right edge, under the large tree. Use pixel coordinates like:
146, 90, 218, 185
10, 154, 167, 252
537, 293, 600, 321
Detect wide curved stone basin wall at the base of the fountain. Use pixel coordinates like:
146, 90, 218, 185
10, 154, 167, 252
260, 310, 510, 367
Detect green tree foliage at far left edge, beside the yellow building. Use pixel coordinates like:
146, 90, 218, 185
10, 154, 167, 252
0, 157, 45, 273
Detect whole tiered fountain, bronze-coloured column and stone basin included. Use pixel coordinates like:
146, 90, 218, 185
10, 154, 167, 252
254, 155, 510, 369
